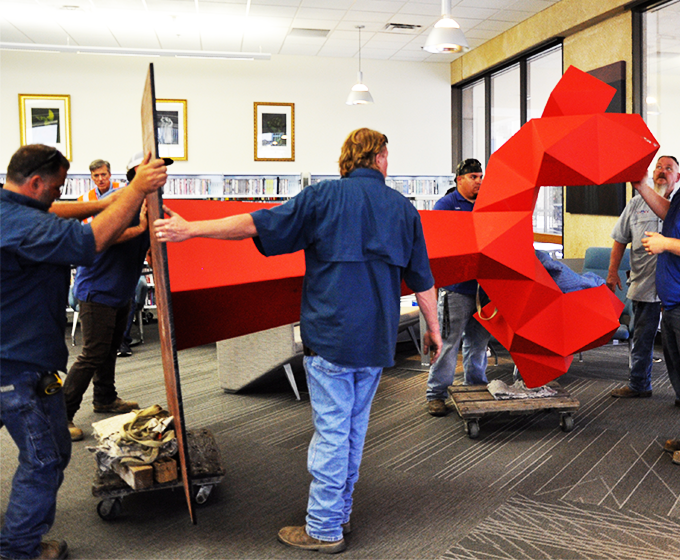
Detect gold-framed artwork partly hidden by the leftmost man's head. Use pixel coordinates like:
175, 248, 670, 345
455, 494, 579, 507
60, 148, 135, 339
19, 93, 71, 161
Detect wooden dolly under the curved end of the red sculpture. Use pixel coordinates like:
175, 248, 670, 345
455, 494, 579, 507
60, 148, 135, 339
448, 381, 581, 439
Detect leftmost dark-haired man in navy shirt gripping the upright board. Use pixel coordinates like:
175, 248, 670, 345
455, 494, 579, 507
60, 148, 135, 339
0, 144, 167, 558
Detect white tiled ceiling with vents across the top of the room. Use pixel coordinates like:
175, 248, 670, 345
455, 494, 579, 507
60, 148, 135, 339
0, 0, 558, 61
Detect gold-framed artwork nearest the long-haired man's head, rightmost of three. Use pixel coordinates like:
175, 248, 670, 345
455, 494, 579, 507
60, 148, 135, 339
254, 102, 295, 161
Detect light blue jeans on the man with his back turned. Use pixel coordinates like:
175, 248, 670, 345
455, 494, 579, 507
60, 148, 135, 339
304, 356, 382, 541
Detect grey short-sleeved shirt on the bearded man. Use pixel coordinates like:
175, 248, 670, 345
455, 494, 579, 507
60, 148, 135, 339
612, 195, 663, 302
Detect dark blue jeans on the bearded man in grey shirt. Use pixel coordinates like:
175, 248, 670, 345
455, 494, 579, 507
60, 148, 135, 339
628, 301, 661, 391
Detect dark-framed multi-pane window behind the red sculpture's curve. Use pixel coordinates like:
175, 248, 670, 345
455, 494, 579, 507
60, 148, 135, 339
454, 44, 562, 235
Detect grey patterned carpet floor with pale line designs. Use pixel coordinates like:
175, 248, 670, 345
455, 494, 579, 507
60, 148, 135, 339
0, 324, 680, 560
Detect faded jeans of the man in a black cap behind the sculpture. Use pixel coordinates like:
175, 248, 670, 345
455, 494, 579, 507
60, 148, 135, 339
427, 290, 491, 401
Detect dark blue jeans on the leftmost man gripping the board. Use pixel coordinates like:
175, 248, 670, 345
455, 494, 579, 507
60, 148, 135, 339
0, 371, 71, 558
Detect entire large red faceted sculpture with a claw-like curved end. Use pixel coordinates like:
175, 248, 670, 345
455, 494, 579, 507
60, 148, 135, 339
166, 67, 659, 387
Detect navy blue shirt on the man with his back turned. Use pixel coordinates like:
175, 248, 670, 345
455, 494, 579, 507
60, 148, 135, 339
251, 169, 434, 367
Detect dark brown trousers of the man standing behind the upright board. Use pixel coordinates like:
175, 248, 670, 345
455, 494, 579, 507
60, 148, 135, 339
64, 301, 130, 421
